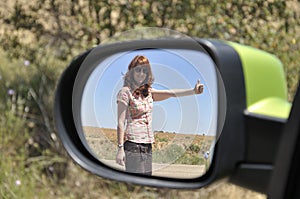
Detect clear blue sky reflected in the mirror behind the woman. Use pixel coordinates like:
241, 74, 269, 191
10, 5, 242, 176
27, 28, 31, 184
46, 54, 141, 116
81, 49, 218, 135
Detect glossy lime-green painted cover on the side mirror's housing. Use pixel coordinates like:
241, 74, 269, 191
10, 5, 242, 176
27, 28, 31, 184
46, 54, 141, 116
226, 42, 291, 119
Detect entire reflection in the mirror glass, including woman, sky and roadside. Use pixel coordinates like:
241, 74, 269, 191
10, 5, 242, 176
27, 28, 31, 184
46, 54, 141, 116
81, 49, 218, 178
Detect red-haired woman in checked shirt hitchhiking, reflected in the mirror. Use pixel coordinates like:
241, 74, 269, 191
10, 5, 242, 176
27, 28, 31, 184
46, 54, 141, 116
116, 55, 203, 175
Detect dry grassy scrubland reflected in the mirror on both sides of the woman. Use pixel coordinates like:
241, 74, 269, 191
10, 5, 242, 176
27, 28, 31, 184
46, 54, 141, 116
83, 127, 214, 165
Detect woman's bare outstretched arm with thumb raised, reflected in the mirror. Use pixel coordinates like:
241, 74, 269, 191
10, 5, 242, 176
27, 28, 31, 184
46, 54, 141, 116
151, 80, 203, 101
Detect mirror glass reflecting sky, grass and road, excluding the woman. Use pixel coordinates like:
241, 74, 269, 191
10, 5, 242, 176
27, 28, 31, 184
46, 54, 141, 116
81, 49, 218, 178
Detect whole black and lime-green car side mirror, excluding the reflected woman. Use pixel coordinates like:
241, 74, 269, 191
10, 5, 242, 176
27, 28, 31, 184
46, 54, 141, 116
55, 28, 290, 193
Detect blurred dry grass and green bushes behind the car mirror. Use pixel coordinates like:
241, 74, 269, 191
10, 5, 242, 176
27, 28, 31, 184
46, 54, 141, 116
0, 0, 300, 198
